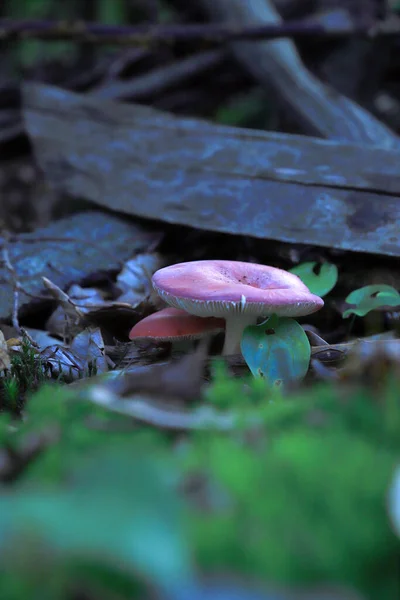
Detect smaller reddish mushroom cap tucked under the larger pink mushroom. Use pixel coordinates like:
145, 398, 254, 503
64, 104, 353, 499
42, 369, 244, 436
129, 308, 225, 345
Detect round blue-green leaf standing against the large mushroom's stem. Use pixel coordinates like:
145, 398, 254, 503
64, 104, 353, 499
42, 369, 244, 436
241, 315, 311, 387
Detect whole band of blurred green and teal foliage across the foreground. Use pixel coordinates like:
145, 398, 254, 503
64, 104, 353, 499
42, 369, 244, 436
0, 367, 400, 600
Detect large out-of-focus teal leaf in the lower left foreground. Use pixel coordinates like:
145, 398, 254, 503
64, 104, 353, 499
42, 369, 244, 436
0, 443, 192, 585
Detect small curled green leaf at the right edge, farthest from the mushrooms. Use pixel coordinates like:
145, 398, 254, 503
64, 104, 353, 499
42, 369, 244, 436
343, 283, 400, 319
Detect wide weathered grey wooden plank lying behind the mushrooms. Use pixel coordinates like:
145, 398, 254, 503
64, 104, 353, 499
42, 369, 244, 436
24, 84, 400, 256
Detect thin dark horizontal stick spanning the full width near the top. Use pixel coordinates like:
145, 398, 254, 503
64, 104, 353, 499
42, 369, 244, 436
0, 16, 400, 47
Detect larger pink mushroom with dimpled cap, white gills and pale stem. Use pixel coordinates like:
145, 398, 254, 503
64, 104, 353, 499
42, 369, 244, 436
152, 260, 324, 355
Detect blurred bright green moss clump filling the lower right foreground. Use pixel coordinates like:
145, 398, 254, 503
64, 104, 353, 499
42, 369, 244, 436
187, 378, 400, 600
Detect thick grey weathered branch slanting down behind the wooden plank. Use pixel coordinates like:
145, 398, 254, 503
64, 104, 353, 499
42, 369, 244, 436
197, 0, 400, 150
